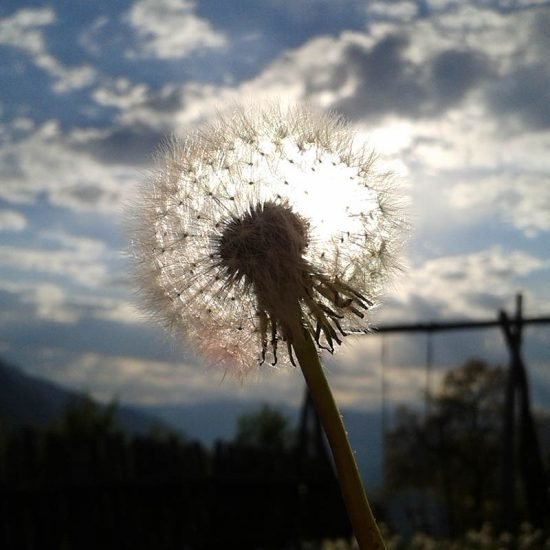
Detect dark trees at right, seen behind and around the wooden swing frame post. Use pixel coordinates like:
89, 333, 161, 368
385, 360, 550, 536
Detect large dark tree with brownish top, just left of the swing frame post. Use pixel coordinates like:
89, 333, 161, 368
386, 360, 505, 534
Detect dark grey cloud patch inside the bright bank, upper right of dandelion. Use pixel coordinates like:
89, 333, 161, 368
333, 35, 490, 122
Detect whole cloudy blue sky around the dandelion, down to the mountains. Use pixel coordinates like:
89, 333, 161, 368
0, 0, 550, 418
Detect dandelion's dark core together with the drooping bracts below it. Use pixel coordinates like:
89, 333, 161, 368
215, 201, 372, 364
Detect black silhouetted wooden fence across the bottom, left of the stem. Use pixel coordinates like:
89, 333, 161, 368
0, 429, 350, 550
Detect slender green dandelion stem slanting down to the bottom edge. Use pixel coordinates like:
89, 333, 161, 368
292, 314, 386, 550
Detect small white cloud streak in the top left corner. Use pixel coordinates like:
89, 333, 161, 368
0, 7, 96, 93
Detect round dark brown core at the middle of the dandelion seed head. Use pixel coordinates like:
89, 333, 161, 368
218, 202, 307, 305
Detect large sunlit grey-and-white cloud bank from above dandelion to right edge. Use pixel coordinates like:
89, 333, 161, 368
80, 3, 550, 177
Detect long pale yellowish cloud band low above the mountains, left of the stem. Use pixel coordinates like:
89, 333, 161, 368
31, 349, 304, 405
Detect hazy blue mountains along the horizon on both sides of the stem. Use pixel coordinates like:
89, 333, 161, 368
0, 359, 382, 488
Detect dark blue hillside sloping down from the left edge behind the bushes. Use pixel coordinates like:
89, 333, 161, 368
0, 359, 166, 435
